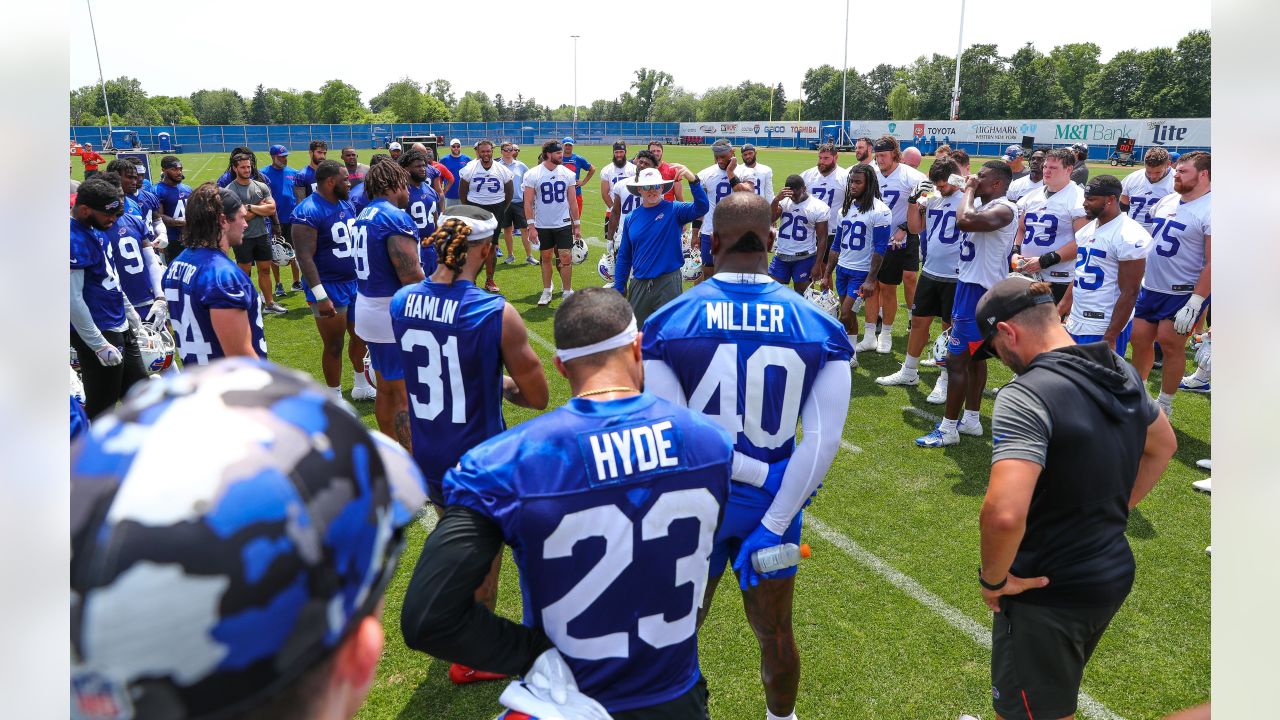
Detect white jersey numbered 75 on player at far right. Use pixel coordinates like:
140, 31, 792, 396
1142, 192, 1213, 295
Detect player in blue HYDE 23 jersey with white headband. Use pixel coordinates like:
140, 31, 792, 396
401, 288, 737, 720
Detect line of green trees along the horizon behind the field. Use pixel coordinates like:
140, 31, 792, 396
70, 29, 1211, 126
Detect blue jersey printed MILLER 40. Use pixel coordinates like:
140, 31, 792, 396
643, 271, 854, 462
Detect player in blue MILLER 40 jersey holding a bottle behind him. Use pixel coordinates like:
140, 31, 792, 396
650, 192, 854, 719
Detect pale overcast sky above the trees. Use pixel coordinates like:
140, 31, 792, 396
69, 0, 1210, 108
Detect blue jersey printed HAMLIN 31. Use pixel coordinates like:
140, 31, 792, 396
392, 279, 507, 483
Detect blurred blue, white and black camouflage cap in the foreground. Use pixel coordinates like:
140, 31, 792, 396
70, 359, 425, 717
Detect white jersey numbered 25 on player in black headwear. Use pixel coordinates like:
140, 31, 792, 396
1066, 214, 1152, 336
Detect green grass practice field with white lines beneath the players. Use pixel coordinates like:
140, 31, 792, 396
102, 146, 1211, 720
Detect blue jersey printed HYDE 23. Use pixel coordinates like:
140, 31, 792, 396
444, 393, 732, 712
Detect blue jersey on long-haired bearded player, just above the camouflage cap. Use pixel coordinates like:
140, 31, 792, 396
163, 247, 266, 365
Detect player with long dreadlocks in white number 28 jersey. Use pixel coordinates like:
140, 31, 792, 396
827, 163, 893, 368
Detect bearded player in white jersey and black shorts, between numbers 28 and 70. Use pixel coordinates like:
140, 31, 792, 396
858, 135, 929, 354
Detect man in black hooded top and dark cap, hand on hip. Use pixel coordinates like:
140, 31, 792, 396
974, 277, 1178, 720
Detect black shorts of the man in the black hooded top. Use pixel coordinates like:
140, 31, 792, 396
991, 597, 1124, 720
